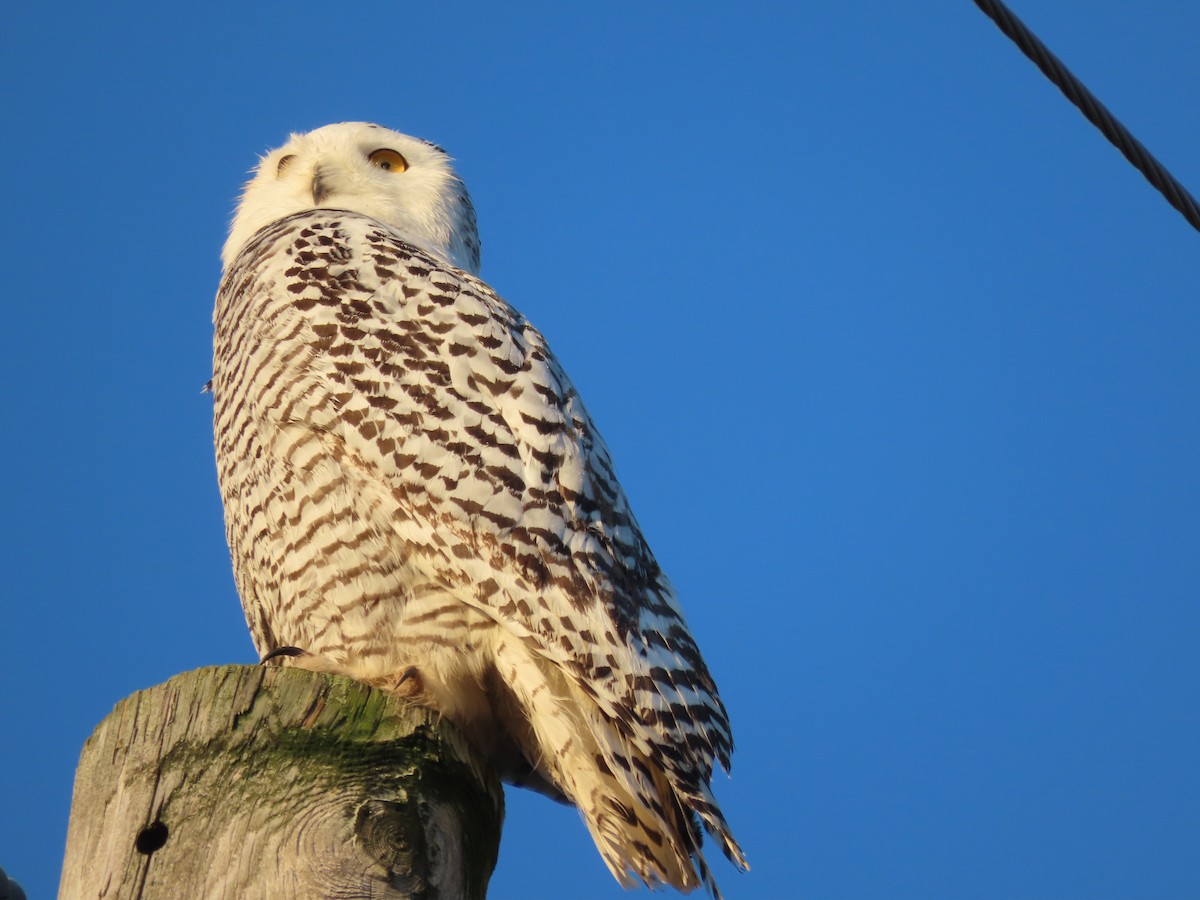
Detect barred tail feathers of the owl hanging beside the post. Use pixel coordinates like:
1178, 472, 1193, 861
496, 636, 745, 898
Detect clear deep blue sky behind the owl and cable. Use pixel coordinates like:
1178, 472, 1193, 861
0, 0, 1200, 900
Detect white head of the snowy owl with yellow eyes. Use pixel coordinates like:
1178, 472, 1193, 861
221, 122, 479, 275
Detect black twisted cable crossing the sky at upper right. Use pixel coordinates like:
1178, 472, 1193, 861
974, 0, 1200, 232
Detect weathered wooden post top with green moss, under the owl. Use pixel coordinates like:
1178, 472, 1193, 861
59, 666, 504, 900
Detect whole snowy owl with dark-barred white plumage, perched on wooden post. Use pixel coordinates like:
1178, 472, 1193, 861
212, 122, 744, 889
